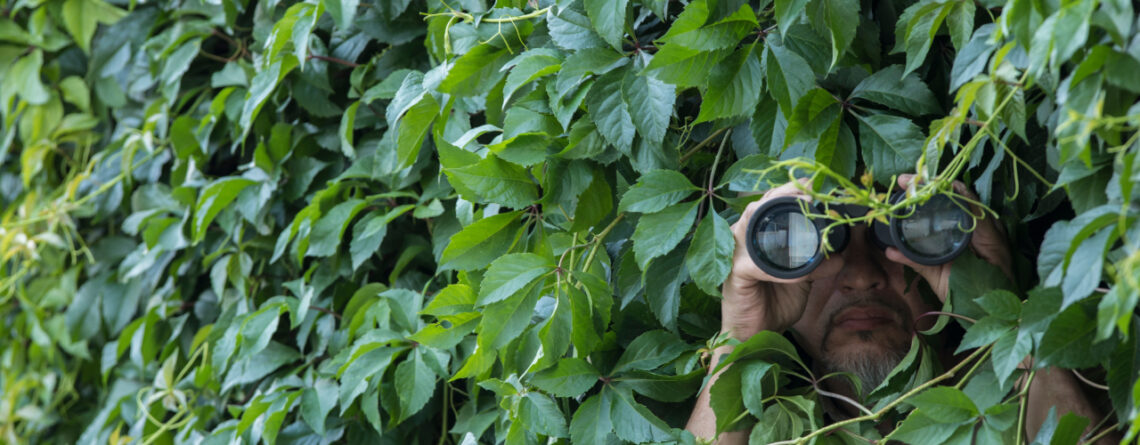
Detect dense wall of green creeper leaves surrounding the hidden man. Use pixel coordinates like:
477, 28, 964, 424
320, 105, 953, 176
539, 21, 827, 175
0, 0, 1140, 444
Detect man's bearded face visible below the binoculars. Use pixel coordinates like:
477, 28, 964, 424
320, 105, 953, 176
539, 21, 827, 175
792, 225, 934, 390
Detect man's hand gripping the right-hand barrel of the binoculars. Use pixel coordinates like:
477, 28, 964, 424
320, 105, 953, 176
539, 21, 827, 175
887, 175, 1013, 302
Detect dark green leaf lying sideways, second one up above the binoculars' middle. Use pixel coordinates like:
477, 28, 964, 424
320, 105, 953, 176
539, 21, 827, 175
850, 65, 941, 115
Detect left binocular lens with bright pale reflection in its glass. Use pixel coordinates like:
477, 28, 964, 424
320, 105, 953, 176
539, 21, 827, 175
756, 211, 820, 269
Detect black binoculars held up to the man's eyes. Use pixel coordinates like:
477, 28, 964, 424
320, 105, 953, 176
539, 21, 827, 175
747, 192, 975, 278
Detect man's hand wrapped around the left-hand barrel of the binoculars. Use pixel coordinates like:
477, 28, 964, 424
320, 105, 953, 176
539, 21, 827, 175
720, 178, 840, 340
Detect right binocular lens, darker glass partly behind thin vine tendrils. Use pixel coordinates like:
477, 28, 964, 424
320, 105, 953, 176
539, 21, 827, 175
896, 195, 972, 262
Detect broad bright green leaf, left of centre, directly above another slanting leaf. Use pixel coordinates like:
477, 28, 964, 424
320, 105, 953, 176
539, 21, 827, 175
445, 154, 538, 209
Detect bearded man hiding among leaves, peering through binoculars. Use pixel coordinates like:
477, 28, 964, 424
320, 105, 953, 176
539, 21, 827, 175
686, 175, 1113, 444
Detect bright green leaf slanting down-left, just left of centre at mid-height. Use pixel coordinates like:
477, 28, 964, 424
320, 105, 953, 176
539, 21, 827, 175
440, 210, 522, 270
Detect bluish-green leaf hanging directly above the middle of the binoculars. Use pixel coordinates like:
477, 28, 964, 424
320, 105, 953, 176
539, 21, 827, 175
858, 114, 926, 184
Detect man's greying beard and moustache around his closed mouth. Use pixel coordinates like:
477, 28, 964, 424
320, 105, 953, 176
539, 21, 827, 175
820, 296, 913, 397
